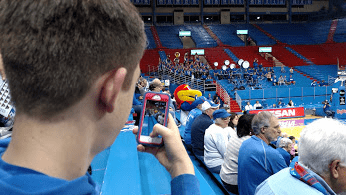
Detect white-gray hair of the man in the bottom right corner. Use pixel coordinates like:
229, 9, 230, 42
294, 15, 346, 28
298, 118, 346, 175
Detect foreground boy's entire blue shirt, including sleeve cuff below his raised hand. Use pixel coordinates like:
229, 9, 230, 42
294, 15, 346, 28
0, 139, 200, 195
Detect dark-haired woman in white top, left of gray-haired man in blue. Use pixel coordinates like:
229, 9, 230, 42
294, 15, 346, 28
220, 114, 255, 194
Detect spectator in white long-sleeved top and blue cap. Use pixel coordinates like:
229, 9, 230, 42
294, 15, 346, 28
204, 109, 232, 174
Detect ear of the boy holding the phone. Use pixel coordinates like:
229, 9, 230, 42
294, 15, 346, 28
99, 68, 127, 113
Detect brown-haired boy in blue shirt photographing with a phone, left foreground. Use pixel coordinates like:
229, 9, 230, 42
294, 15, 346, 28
0, 0, 199, 194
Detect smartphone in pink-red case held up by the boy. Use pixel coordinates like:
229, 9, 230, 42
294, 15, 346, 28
137, 92, 171, 146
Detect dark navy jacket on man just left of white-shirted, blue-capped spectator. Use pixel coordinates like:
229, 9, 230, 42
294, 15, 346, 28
191, 113, 213, 156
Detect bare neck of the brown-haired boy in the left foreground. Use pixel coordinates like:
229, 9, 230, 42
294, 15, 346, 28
2, 115, 96, 180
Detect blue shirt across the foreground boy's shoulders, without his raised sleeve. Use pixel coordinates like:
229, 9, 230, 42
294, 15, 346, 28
0, 139, 99, 195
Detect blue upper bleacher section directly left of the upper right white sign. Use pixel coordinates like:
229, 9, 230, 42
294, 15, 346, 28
209, 24, 245, 46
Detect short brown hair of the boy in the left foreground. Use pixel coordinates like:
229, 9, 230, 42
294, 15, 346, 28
0, 0, 146, 118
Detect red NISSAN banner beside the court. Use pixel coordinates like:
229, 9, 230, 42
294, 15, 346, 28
249, 107, 305, 118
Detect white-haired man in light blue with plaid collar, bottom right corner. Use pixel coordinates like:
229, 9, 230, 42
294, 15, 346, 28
256, 118, 346, 195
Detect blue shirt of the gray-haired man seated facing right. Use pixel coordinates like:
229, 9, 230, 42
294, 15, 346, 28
238, 135, 287, 195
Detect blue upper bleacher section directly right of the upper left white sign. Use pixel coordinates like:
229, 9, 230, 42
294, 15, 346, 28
183, 25, 217, 48
